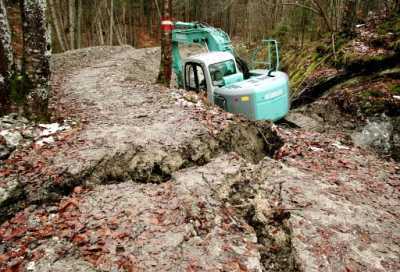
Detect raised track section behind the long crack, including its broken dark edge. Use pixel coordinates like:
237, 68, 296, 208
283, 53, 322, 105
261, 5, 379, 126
0, 47, 282, 220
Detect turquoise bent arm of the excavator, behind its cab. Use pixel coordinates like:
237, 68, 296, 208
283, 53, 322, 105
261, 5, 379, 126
172, 22, 249, 87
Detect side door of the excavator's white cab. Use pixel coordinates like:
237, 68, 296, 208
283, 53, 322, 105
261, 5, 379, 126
185, 62, 207, 94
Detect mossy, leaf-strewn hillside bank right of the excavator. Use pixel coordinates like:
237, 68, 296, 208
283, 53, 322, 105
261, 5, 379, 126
284, 12, 400, 160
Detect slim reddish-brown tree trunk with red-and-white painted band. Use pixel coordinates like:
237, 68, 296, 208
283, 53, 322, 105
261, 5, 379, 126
157, 0, 172, 87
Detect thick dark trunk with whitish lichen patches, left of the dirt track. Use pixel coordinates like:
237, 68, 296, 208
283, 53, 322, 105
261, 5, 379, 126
21, 0, 51, 120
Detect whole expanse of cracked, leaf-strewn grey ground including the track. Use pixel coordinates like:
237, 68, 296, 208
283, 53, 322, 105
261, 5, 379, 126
0, 47, 400, 271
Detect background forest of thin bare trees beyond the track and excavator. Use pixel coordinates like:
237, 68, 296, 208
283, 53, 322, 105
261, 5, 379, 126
1, 0, 399, 52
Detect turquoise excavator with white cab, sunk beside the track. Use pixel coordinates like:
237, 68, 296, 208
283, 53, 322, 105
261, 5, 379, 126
172, 22, 289, 121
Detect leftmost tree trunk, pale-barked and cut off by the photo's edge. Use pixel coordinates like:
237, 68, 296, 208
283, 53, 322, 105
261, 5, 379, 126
0, 0, 13, 114
